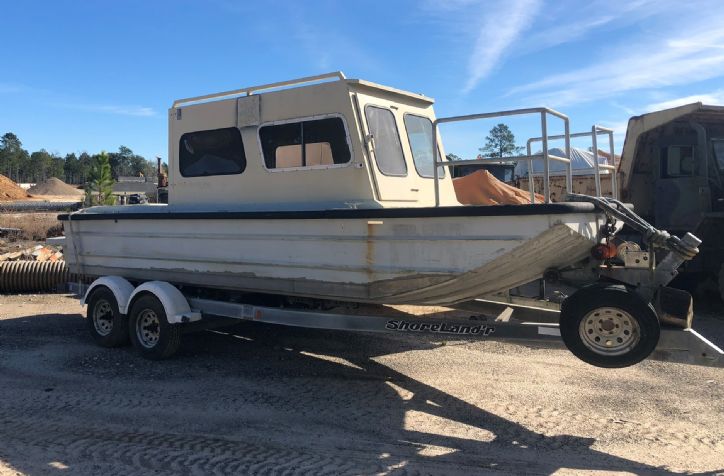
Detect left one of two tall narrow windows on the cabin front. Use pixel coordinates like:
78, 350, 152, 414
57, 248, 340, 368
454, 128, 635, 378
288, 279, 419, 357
365, 106, 407, 177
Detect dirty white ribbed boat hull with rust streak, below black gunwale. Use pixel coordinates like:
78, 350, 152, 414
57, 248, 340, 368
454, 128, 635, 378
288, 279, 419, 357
64, 207, 604, 304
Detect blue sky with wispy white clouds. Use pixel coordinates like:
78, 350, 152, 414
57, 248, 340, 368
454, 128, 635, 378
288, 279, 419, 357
0, 0, 724, 159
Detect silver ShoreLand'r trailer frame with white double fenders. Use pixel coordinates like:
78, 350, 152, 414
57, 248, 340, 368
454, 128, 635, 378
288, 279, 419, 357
71, 276, 724, 367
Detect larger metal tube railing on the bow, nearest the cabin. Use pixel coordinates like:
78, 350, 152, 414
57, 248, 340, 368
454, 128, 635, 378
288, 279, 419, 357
432, 107, 573, 207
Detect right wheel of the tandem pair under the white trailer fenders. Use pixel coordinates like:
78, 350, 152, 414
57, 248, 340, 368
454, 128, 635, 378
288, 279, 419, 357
128, 294, 181, 360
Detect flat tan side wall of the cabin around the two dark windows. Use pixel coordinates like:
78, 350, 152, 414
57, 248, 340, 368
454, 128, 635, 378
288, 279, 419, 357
169, 82, 374, 205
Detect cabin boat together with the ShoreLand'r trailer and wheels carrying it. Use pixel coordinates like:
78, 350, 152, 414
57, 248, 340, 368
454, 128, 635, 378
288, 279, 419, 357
59, 72, 721, 367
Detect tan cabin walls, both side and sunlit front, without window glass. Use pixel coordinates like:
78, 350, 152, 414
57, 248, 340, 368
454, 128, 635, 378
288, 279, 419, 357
169, 81, 459, 207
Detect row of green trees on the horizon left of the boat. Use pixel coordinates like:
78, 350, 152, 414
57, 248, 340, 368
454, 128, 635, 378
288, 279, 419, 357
0, 132, 156, 185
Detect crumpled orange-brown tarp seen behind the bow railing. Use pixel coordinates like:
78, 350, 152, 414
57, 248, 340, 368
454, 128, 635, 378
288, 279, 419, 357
453, 170, 543, 205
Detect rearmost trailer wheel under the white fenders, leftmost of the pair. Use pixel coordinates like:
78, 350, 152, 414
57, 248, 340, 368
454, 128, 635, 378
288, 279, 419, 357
86, 286, 128, 347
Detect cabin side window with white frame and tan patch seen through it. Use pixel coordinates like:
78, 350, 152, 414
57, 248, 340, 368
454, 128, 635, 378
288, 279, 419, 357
259, 117, 352, 169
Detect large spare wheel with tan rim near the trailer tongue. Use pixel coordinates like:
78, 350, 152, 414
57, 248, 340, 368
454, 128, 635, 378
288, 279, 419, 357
560, 285, 660, 368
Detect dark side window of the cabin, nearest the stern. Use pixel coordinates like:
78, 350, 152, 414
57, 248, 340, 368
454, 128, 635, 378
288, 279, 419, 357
179, 127, 246, 177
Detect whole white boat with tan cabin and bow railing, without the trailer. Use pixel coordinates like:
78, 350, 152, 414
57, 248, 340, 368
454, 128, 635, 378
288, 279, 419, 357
59, 72, 656, 305
